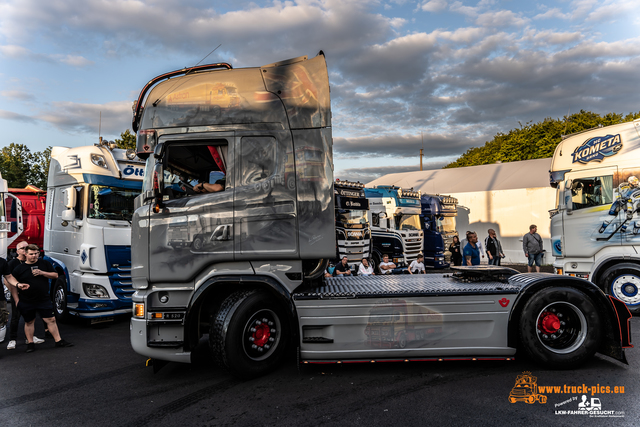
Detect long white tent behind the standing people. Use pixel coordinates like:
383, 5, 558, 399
367, 158, 556, 263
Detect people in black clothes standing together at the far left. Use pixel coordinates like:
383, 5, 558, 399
0, 241, 73, 353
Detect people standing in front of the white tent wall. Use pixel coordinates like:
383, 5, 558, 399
449, 224, 544, 273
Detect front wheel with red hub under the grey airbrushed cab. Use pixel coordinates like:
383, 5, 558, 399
209, 290, 290, 378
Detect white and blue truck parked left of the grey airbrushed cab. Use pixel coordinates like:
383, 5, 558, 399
44, 140, 144, 323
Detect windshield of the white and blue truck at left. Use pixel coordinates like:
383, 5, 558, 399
88, 185, 140, 221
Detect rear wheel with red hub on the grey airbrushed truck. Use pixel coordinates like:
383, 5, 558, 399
520, 287, 601, 369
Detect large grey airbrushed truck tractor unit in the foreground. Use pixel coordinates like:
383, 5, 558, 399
131, 52, 631, 378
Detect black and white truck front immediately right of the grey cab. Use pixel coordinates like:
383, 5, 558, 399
333, 179, 371, 272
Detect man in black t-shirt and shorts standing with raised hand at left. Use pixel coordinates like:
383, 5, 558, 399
13, 245, 73, 353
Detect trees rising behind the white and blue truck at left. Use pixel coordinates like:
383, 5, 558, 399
0, 129, 136, 190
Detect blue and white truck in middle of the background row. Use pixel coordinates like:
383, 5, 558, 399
364, 185, 424, 270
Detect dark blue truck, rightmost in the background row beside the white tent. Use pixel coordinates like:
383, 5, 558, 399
420, 194, 458, 268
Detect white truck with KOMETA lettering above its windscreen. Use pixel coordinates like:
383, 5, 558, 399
550, 119, 640, 314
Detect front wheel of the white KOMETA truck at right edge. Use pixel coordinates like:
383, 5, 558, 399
600, 263, 640, 316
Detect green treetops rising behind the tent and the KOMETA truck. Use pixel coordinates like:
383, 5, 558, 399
444, 110, 640, 168
